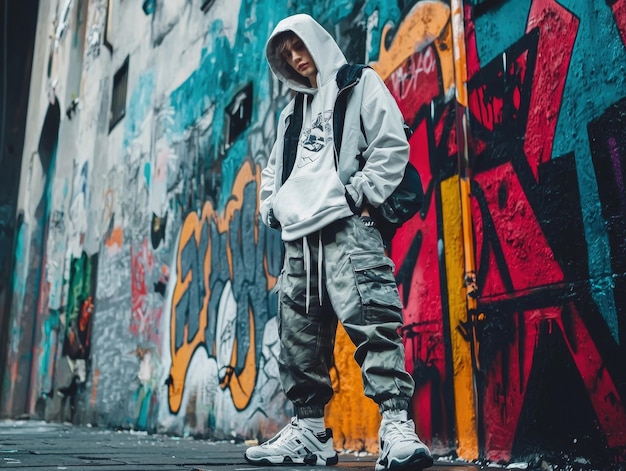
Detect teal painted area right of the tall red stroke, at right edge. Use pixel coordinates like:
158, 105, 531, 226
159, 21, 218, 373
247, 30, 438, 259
552, 0, 626, 338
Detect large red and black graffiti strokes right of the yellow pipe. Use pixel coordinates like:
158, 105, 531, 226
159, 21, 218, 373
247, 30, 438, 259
467, 0, 626, 460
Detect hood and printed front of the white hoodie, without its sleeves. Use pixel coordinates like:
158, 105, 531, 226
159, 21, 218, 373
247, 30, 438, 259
266, 15, 352, 241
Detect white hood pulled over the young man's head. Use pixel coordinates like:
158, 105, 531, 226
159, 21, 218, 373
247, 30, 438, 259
265, 13, 347, 93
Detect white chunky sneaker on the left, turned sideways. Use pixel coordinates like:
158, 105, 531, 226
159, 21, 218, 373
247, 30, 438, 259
245, 417, 339, 466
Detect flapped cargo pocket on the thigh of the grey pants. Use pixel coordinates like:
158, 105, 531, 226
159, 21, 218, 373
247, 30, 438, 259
350, 252, 402, 318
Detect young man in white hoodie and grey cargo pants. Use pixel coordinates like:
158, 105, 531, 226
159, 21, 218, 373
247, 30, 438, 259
245, 14, 432, 471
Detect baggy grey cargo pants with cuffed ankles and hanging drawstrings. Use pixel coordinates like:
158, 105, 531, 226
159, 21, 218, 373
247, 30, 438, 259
279, 216, 414, 418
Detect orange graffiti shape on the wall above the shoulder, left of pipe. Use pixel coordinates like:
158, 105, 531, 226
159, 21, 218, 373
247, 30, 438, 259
370, 0, 454, 92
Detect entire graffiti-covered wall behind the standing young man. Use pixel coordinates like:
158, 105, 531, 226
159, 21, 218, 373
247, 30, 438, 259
1, 0, 626, 463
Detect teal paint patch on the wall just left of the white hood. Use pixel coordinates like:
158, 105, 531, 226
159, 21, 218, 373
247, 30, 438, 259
164, 0, 288, 210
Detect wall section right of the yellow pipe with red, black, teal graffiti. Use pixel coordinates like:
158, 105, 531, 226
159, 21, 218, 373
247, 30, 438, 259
467, 0, 626, 464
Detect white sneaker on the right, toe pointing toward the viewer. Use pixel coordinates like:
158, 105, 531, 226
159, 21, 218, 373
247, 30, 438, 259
376, 416, 433, 471
